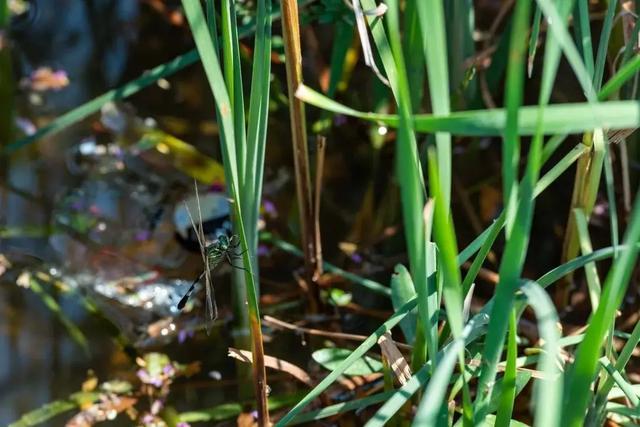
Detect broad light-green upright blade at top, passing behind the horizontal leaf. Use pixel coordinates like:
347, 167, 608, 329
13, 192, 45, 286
413, 0, 455, 210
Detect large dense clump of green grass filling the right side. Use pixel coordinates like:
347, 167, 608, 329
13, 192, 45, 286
278, 0, 640, 426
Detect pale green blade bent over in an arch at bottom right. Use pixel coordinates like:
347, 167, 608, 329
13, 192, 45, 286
521, 281, 563, 427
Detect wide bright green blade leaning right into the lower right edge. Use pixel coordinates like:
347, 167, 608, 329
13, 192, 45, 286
563, 189, 640, 426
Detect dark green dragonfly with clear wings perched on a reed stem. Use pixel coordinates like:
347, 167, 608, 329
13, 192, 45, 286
177, 183, 247, 325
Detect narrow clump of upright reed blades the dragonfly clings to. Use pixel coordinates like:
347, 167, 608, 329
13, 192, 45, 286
183, 0, 271, 426
